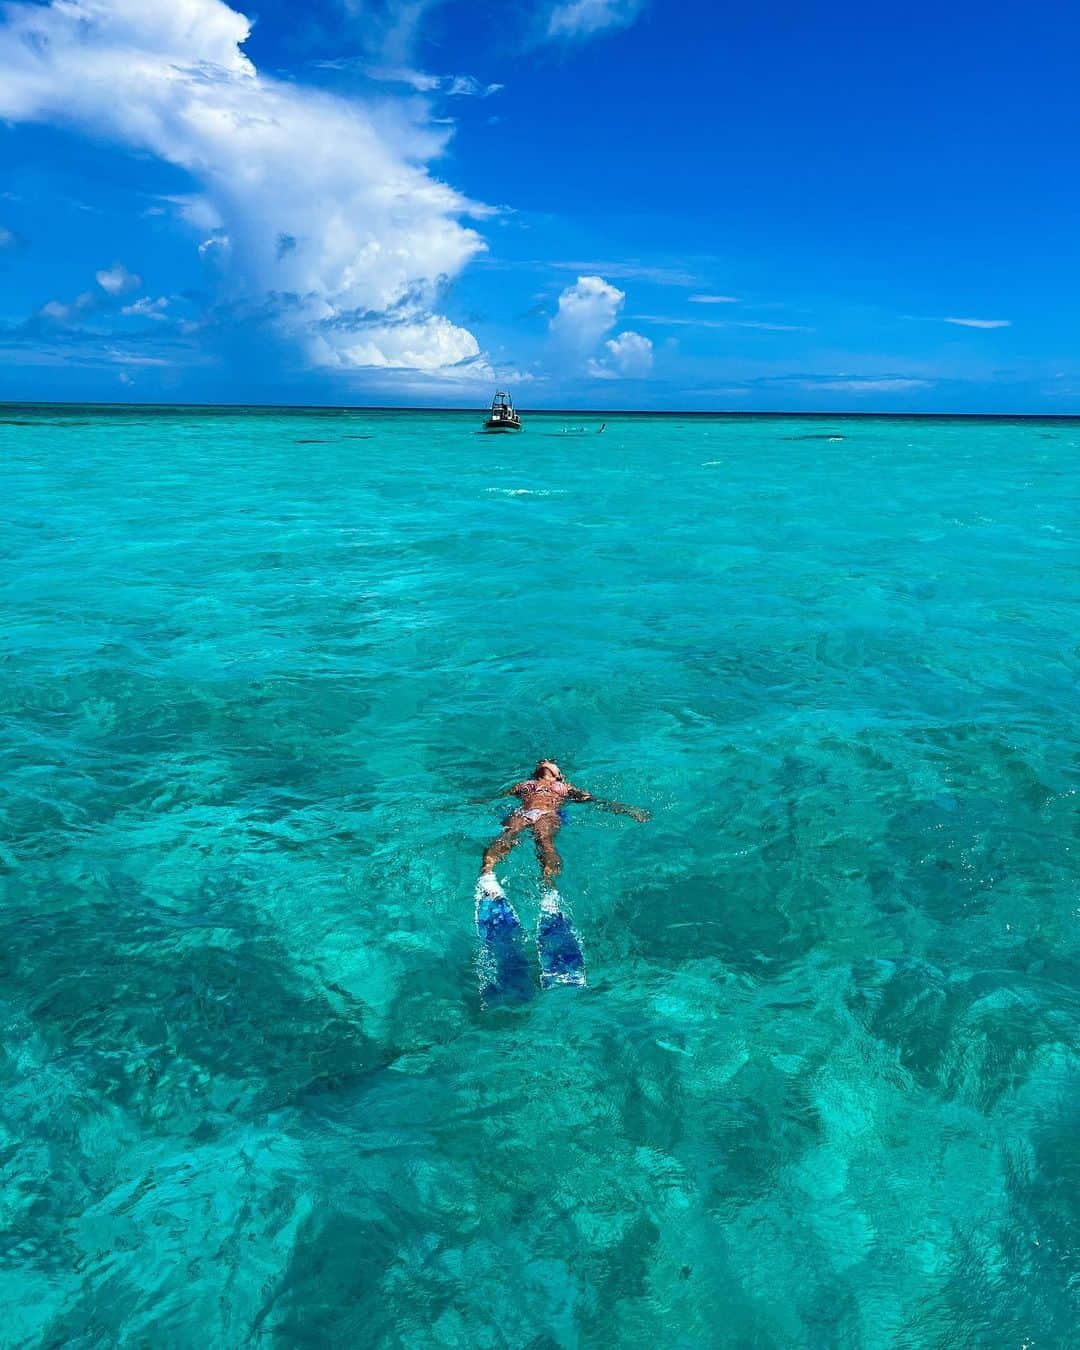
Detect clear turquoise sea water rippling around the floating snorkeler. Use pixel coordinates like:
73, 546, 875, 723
0, 408, 1080, 1350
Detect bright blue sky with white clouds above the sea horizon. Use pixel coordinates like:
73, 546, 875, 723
0, 0, 1080, 412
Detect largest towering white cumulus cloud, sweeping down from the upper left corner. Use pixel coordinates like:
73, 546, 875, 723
0, 0, 485, 370
